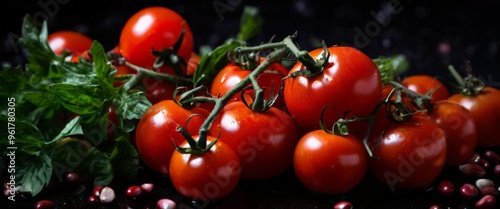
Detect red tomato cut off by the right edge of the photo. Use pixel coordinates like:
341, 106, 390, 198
448, 87, 500, 148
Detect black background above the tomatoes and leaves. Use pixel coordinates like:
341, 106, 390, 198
0, 0, 500, 87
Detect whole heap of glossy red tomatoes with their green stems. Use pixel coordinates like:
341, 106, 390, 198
48, 7, 500, 206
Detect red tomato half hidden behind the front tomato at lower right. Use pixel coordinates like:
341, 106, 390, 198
425, 100, 477, 166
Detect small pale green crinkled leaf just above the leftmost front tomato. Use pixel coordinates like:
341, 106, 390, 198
116, 91, 152, 120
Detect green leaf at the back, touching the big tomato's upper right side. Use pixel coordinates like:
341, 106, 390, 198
373, 54, 409, 84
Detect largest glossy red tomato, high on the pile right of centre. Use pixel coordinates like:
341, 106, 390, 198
284, 46, 382, 131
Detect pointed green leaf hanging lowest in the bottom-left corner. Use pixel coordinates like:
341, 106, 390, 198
16, 153, 52, 196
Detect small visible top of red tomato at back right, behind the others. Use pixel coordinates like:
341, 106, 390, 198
401, 75, 450, 102
